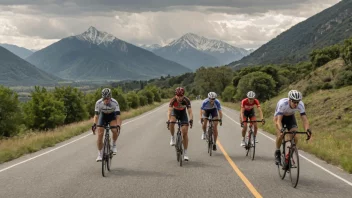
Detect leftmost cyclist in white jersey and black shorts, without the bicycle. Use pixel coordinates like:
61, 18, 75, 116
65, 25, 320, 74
92, 88, 121, 162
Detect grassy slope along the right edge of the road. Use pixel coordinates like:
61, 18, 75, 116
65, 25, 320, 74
224, 86, 352, 173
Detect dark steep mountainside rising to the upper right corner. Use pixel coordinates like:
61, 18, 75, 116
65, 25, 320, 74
229, 0, 352, 67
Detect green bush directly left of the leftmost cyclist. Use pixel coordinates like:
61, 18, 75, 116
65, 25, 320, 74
54, 87, 88, 124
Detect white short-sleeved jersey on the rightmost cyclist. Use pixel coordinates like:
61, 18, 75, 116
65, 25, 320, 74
274, 98, 306, 116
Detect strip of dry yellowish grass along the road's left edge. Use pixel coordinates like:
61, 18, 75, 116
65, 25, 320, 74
0, 100, 168, 164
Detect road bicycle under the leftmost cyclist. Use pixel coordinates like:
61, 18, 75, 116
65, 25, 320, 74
98, 122, 120, 177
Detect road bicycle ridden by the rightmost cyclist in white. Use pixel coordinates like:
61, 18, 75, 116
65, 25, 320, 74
277, 128, 311, 188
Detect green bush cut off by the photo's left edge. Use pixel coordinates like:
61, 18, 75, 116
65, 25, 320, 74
0, 85, 21, 138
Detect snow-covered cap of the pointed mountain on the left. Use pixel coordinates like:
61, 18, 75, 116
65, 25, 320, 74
76, 26, 117, 45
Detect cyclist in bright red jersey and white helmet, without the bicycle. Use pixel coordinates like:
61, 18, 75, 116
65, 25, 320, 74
240, 91, 265, 146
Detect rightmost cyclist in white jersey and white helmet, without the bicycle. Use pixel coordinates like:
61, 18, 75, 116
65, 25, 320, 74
274, 90, 312, 165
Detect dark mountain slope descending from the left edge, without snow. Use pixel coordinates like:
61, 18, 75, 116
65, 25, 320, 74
0, 46, 61, 86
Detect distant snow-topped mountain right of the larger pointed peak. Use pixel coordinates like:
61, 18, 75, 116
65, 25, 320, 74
153, 33, 249, 70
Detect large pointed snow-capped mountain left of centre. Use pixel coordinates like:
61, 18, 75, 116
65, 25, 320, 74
26, 27, 190, 80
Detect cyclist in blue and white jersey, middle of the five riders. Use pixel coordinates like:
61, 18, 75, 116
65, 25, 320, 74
200, 92, 222, 151
